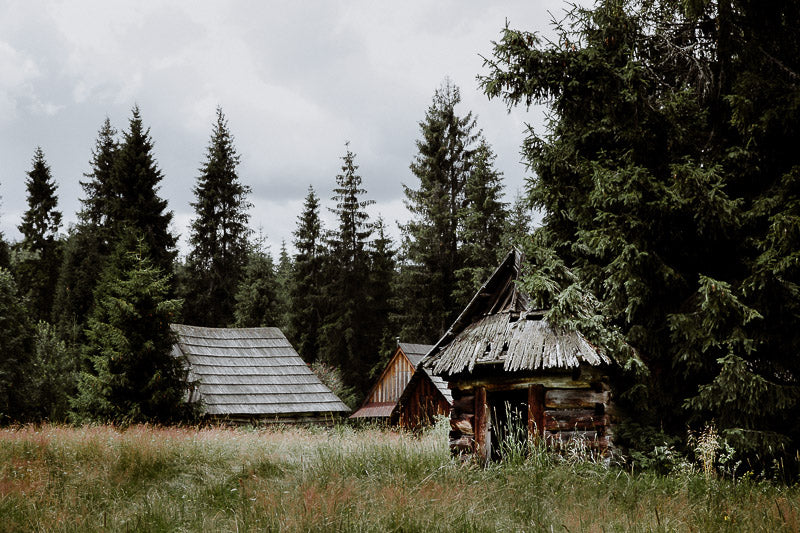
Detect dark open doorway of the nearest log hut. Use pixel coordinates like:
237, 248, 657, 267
486, 389, 530, 461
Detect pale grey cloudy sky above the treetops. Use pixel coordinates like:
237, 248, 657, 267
0, 0, 564, 253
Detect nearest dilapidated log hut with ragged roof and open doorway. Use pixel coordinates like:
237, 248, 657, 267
422, 250, 613, 461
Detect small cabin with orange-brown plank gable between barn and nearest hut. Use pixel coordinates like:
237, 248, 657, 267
350, 342, 444, 423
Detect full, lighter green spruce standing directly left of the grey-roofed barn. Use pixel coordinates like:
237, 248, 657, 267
72, 232, 191, 423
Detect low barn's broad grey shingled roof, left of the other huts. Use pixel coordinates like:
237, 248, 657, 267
171, 324, 350, 423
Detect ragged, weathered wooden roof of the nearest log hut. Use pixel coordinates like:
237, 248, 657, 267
423, 250, 611, 375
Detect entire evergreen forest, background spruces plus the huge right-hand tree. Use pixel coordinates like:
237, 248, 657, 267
0, 0, 800, 475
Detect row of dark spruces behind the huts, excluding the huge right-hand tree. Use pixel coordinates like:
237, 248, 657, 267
0, 79, 530, 422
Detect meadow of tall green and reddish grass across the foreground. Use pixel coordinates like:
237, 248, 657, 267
0, 426, 800, 532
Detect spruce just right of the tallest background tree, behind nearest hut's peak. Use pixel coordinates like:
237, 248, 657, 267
454, 139, 508, 307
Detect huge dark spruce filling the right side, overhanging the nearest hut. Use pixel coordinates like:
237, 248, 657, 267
482, 0, 800, 466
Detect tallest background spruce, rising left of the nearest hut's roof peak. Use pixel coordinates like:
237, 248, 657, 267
399, 79, 477, 342
